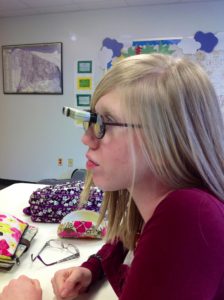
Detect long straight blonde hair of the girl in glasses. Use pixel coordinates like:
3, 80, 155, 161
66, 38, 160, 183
82, 54, 224, 249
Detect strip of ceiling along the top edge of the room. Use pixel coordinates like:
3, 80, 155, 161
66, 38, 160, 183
0, 0, 224, 18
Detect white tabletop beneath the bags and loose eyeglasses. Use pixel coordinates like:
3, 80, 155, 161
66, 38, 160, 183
0, 183, 117, 300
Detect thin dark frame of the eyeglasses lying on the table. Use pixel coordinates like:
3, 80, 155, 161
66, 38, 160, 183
31, 239, 80, 267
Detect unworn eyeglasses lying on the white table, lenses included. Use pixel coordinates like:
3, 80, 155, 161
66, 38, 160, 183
31, 239, 80, 266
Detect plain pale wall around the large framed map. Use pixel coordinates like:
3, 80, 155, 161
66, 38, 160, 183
0, 2, 224, 181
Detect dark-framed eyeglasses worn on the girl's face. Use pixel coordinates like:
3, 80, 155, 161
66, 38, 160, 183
83, 114, 141, 139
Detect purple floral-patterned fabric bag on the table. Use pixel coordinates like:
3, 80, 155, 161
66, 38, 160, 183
23, 181, 103, 223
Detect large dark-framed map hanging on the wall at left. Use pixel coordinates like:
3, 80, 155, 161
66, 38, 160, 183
2, 42, 63, 95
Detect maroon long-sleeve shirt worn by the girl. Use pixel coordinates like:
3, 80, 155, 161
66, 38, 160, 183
83, 189, 224, 300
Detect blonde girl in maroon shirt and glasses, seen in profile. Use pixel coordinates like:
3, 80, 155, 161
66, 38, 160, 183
0, 54, 224, 300
